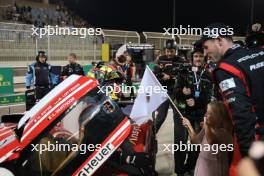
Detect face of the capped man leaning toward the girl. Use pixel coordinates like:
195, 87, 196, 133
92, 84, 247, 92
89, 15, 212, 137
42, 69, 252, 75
203, 39, 221, 63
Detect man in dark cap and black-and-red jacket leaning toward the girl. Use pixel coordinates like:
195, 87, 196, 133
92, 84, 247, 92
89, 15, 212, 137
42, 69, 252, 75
200, 23, 264, 175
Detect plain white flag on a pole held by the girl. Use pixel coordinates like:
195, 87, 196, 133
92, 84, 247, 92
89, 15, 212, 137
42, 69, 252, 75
130, 66, 168, 124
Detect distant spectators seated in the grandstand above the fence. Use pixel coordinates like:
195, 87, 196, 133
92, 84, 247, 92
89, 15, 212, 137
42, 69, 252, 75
3, 1, 89, 27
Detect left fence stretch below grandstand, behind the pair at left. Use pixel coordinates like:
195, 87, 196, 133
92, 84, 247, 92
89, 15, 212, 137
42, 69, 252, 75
0, 23, 102, 66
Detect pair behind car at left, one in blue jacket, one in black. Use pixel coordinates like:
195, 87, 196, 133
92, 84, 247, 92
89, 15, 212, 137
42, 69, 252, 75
25, 51, 84, 110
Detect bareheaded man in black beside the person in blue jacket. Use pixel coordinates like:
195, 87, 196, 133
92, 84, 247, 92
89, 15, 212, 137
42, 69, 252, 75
61, 53, 84, 80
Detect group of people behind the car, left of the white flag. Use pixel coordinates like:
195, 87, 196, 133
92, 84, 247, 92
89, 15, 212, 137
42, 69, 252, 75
25, 48, 136, 109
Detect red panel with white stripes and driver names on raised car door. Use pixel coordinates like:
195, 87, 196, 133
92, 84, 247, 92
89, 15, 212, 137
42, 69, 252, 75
21, 76, 97, 147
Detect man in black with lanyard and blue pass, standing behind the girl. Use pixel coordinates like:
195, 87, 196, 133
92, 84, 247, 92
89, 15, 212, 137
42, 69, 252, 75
173, 47, 213, 175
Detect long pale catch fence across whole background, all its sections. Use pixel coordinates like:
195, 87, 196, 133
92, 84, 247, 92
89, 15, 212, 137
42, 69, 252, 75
0, 22, 248, 67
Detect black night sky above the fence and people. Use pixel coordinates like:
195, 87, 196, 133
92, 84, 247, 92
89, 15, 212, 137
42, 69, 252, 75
67, 0, 264, 35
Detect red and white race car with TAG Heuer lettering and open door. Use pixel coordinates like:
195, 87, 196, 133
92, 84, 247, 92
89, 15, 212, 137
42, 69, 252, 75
0, 75, 157, 176
